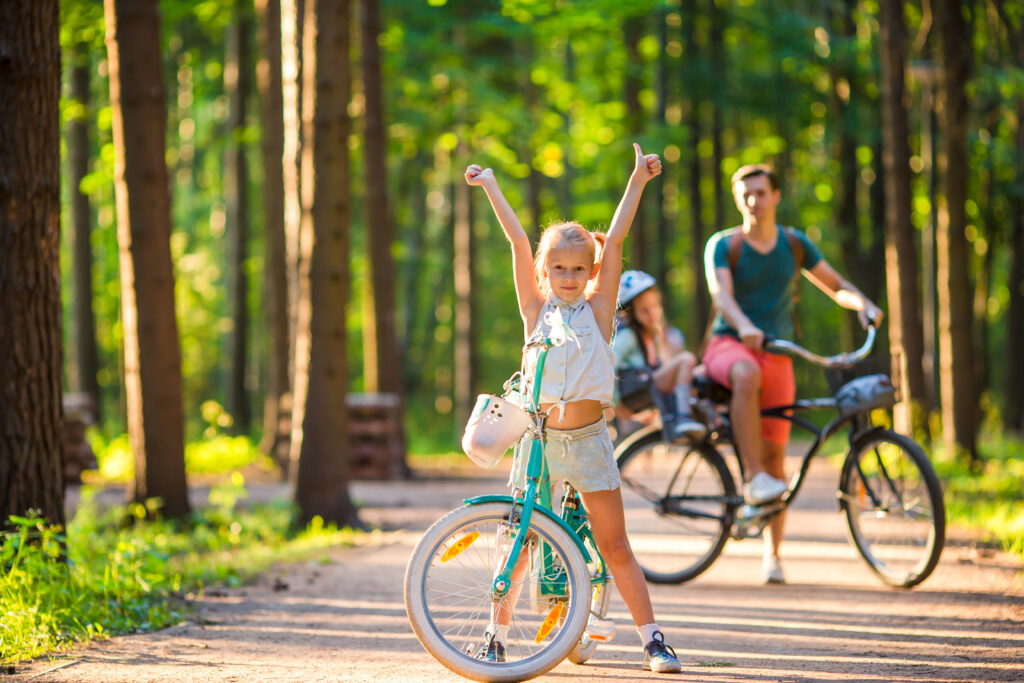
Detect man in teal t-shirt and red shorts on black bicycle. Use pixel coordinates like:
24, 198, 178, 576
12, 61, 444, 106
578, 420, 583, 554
703, 164, 882, 584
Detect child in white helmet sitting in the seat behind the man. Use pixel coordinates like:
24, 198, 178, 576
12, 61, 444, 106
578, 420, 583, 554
611, 270, 707, 440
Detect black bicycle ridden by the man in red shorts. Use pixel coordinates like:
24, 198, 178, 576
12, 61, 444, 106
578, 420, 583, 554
615, 327, 946, 588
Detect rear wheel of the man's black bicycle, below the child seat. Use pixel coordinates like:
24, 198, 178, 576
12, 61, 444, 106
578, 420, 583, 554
617, 430, 739, 584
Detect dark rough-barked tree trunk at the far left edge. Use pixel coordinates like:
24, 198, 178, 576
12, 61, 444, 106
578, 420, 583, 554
0, 0, 65, 528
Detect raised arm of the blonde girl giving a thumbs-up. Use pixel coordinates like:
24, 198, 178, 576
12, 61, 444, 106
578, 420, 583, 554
590, 142, 662, 339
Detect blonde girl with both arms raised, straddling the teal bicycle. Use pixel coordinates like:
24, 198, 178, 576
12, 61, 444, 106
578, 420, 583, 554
466, 143, 680, 673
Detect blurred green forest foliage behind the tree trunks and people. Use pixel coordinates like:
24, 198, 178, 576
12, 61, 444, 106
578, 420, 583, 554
54, 0, 1024, 452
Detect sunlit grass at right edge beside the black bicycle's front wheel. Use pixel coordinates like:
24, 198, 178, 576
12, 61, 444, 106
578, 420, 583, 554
934, 433, 1024, 558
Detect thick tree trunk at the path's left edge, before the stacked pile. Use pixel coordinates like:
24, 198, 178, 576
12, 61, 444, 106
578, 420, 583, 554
292, 0, 359, 526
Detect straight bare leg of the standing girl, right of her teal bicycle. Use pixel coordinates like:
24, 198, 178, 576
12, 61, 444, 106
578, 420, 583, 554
580, 488, 654, 627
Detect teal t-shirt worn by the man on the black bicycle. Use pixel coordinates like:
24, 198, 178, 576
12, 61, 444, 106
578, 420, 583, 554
705, 227, 821, 339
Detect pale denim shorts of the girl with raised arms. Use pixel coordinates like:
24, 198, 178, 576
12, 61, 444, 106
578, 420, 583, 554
509, 418, 622, 494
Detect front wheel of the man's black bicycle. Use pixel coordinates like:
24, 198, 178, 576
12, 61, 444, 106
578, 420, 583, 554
840, 428, 946, 588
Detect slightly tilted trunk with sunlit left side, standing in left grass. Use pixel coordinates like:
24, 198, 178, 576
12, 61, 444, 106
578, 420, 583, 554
104, 0, 189, 517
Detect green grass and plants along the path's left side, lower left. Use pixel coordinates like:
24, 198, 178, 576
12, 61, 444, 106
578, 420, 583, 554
0, 474, 357, 663
